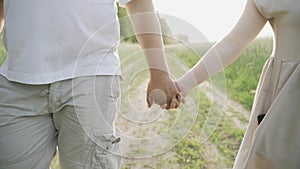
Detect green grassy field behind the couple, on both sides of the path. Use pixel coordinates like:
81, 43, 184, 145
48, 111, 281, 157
0, 39, 272, 169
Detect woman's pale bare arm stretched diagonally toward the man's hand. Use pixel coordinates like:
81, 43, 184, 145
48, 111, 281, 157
177, 0, 267, 95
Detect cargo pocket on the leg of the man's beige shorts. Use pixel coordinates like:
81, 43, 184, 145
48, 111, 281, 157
95, 134, 121, 169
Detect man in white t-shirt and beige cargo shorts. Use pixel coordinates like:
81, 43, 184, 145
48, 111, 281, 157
0, 0, 180, 169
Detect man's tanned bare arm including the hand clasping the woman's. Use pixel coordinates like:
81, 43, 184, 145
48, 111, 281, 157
126, 0, 181, 109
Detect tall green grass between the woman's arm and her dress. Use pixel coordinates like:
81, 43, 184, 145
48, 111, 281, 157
225, 39, 273, 109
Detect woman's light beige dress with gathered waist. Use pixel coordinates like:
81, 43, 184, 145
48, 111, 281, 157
234, 0, 300, 169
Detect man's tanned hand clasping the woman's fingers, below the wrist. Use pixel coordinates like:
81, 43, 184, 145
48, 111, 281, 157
147, 69, 183, 110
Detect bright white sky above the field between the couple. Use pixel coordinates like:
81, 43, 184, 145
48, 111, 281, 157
154, 0, 272, 41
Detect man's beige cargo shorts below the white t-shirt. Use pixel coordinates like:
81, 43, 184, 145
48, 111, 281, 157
0, 76, 121, 169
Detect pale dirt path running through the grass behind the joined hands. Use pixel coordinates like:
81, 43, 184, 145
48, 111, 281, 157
116, 50, 250, 169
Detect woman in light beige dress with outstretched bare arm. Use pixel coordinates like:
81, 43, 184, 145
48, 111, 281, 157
176, 0, 300, 169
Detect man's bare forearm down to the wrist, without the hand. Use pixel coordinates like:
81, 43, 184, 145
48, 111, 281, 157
126, 0, 168, 77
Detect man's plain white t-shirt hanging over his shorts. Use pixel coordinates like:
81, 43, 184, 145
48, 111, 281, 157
0, 0, 130, 84
